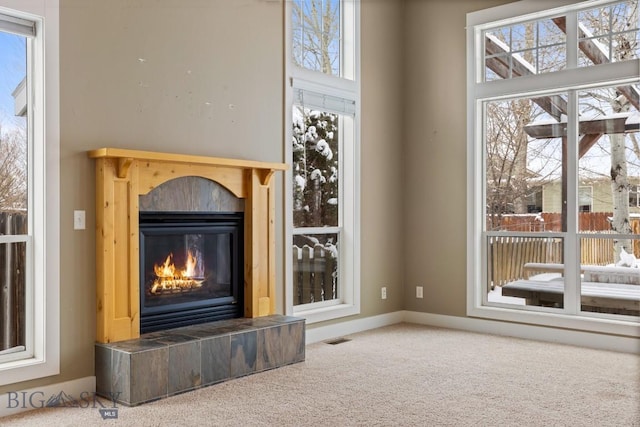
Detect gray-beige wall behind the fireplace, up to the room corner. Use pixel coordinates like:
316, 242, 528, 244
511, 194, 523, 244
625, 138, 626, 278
0, 0, 402, 393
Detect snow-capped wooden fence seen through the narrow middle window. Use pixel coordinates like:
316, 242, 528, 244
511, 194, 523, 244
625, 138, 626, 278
293, 244, 338, 305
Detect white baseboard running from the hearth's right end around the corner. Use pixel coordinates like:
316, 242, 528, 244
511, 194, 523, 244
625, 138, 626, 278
306, 311, 640, 354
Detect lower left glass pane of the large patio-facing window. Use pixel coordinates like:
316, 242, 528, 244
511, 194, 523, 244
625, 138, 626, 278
484, 94, 567, 309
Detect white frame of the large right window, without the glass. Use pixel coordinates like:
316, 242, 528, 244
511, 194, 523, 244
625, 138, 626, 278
467, 0, 640, 337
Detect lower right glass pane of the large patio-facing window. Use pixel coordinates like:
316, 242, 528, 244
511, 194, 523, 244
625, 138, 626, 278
578, 85, 640, 316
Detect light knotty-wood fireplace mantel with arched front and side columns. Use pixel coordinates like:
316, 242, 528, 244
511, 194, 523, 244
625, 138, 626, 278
88, 148, 287, 343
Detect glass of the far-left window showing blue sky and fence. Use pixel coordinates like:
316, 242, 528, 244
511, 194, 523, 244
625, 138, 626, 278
0, 31, 28, 357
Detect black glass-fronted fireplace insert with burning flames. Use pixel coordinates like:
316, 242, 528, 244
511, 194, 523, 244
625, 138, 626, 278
139, 212, 244, 333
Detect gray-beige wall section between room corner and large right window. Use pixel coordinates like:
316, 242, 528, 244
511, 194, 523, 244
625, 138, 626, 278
403, 0, 510, 316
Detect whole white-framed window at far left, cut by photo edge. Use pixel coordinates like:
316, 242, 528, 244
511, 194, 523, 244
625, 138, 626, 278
0, 0, 59, 385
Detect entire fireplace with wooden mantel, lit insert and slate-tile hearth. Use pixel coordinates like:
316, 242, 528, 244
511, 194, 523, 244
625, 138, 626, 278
89, 148, 305, 406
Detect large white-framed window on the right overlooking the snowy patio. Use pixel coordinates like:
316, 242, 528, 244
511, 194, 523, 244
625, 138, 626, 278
467, 0, 640, 335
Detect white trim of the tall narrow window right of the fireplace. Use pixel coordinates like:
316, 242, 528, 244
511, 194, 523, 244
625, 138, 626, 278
284, 1, 360, 324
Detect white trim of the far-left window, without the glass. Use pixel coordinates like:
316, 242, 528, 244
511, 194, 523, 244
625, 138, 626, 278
0, 0, 60, 385
